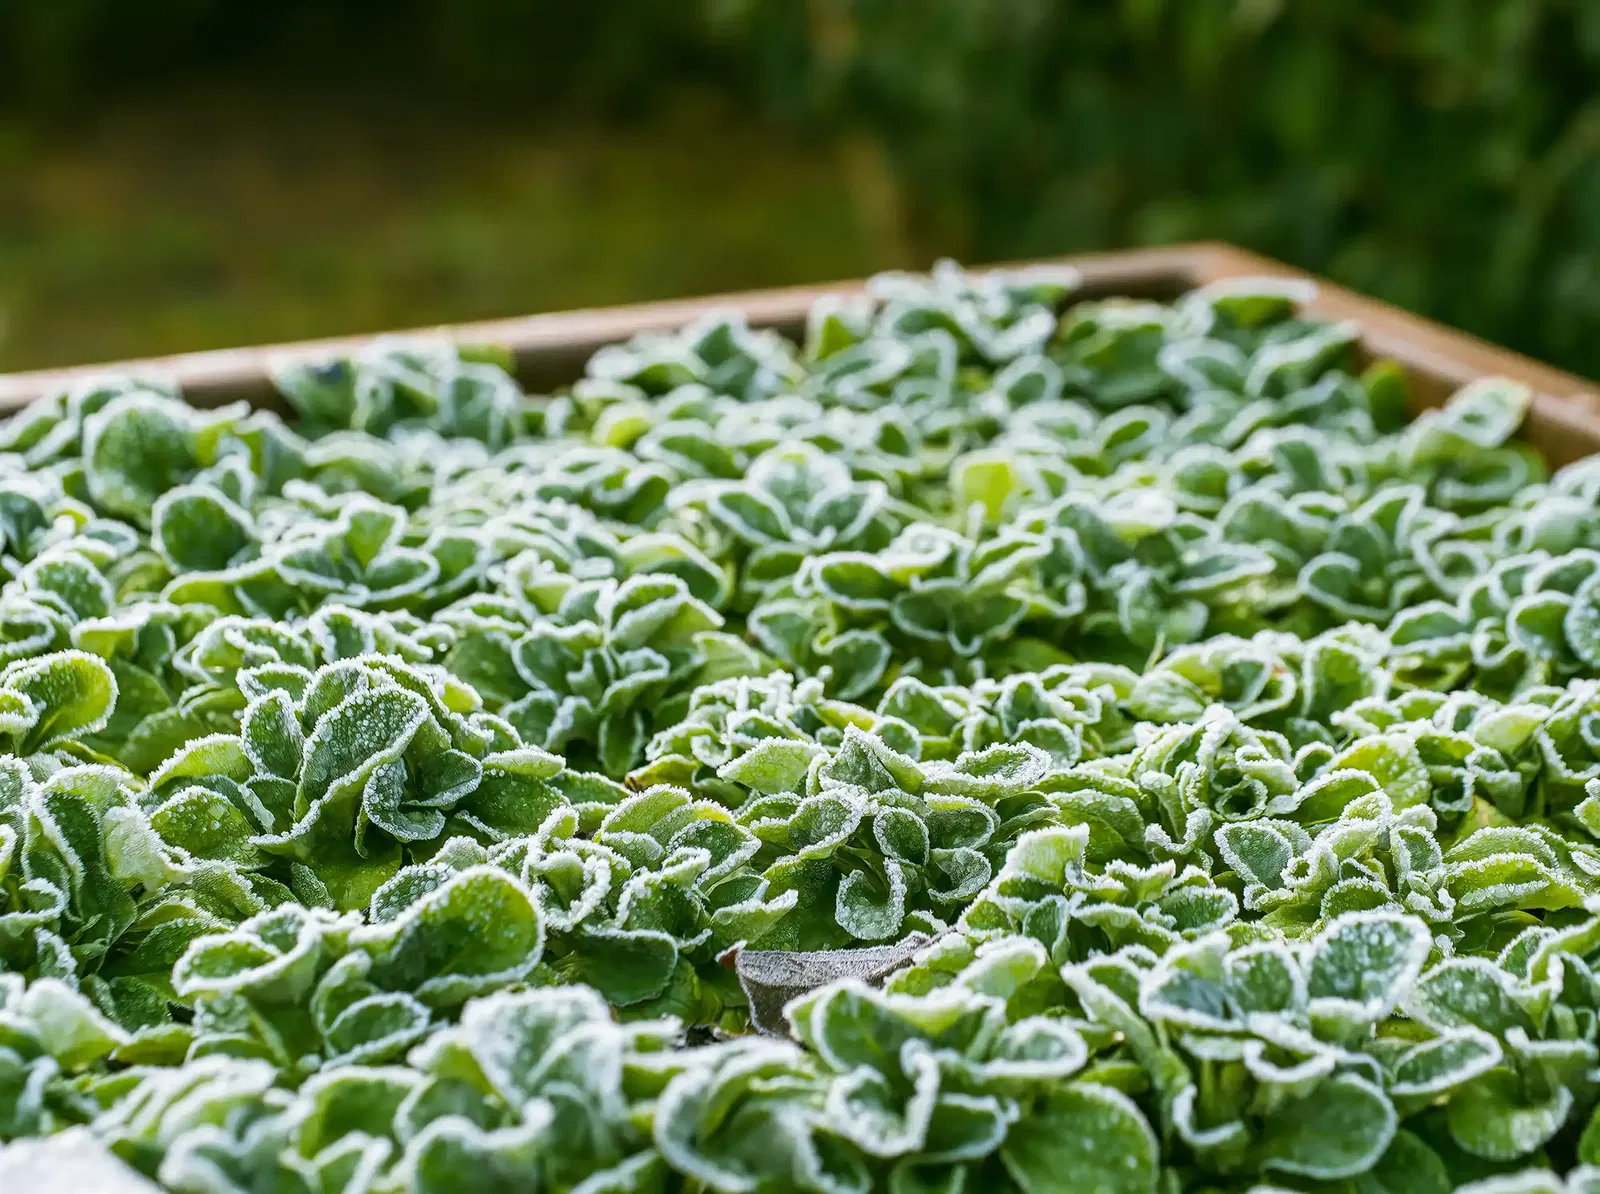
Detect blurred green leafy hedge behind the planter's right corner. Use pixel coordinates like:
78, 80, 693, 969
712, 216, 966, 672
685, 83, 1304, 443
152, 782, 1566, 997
725, 0, 1600, 375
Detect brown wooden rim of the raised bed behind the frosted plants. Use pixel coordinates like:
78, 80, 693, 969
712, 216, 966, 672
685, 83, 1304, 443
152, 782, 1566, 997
0, 243, 1600, 464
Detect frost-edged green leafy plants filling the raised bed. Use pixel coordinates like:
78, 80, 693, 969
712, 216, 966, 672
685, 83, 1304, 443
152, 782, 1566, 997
0, 267, 1600, 1194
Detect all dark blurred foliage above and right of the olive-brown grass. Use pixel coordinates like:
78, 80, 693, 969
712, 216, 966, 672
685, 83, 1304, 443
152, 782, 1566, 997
0, 0, 1600, 375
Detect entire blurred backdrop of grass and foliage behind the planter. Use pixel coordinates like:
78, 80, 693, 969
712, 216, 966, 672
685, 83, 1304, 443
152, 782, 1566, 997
0, 0, 1600, 376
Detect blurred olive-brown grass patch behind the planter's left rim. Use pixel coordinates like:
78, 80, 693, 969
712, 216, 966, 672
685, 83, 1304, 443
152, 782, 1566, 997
0, 85, 907, 370
